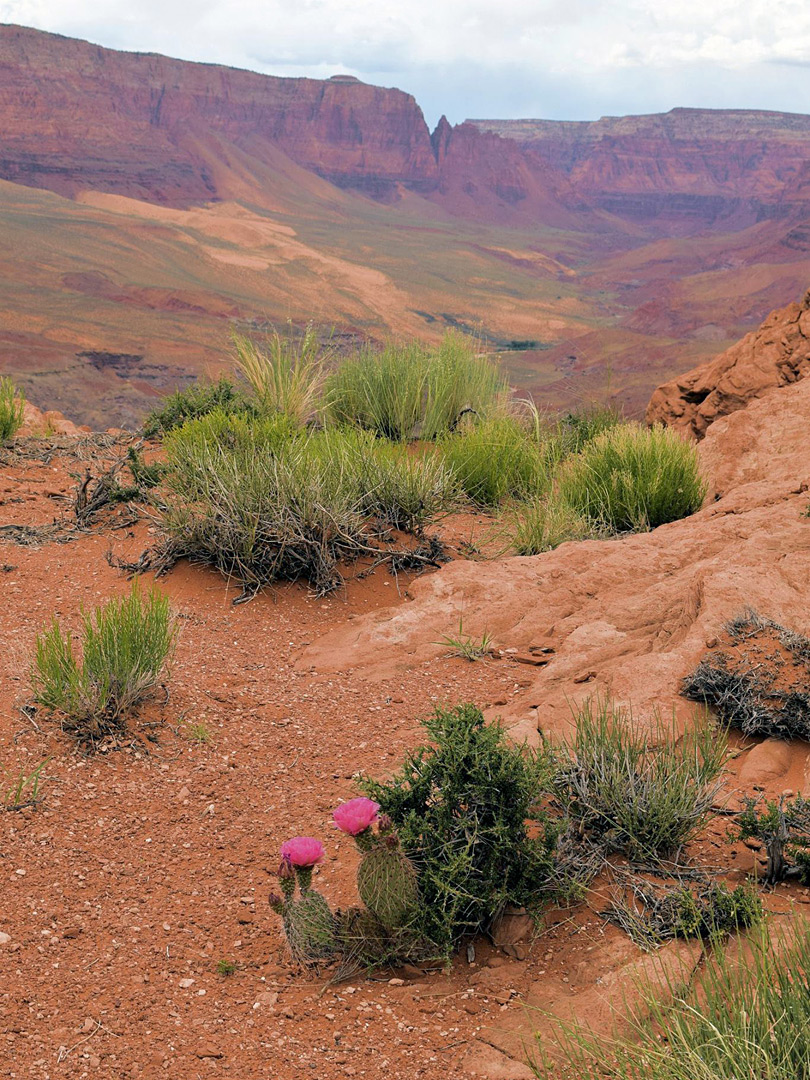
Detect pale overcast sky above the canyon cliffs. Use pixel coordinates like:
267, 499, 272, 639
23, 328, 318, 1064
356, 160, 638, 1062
0, 0, 810, 125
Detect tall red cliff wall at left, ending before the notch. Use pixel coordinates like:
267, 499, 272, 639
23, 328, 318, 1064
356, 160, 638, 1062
0, 26, 436, 206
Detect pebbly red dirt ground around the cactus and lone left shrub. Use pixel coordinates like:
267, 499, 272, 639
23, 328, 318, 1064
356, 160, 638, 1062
0, 432, 808, 1080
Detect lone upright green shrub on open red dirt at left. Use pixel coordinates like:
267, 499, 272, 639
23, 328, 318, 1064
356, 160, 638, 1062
31, 582, 176, 741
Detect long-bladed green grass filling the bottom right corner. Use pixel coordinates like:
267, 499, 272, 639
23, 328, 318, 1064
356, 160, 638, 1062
535, 921, 810, 1080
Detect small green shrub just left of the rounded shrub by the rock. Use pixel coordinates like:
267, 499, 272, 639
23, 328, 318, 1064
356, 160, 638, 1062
442, 416, 545, 507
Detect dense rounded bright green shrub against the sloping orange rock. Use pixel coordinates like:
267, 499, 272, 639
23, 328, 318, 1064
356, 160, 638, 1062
558, 423, 706, 532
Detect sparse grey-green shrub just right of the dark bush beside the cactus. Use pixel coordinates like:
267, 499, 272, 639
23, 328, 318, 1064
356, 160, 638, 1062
553, 699, 727, 861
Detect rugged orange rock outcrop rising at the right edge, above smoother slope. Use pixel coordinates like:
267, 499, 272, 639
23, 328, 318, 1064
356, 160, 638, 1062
647, 292, 810, 438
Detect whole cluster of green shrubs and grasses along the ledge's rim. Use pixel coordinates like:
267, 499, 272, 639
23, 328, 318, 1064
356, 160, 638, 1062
136, 326, 705, 592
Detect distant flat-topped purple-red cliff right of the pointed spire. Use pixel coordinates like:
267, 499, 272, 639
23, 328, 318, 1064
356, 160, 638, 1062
470, 109, 810, 227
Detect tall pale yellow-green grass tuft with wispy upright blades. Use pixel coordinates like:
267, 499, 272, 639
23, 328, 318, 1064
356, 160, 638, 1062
233, 324, 327, 424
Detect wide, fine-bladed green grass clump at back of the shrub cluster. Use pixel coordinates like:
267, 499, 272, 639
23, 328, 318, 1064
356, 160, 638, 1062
326, 332, 509, 442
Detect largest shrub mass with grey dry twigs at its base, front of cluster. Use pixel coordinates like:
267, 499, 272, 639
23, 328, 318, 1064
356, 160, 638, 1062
163, 413, 455, 592
